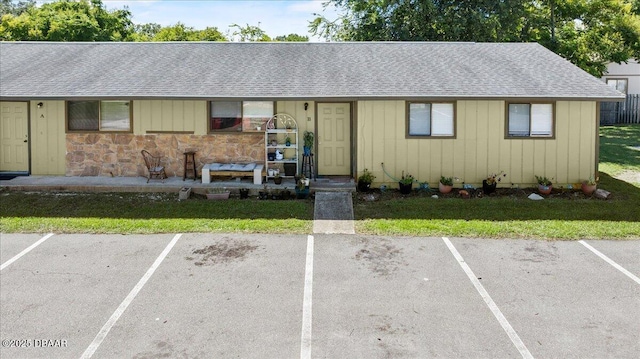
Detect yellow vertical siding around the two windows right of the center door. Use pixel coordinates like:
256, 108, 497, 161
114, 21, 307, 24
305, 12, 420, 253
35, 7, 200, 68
356, 101, 596, 186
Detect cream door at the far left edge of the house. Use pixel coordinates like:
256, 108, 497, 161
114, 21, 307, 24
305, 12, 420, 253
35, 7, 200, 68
0, 102, 29, 172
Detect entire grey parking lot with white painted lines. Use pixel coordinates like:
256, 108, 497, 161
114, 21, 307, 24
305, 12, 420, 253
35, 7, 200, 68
0, 234, 640, 358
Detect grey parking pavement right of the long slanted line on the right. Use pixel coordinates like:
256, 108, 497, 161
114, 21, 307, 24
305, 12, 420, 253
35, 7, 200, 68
452, 239, 640, 358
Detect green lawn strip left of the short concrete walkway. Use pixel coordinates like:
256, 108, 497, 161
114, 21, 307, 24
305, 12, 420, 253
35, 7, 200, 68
0, 191, 313, 233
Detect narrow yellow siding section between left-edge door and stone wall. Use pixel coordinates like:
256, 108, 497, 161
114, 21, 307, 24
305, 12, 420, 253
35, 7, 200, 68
29, 101, 67, 175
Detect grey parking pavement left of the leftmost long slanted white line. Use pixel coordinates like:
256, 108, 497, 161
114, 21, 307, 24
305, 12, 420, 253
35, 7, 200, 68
0, 235, 176, 358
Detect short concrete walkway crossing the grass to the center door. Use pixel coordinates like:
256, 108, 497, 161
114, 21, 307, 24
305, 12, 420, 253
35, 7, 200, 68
313, 192, 355, 234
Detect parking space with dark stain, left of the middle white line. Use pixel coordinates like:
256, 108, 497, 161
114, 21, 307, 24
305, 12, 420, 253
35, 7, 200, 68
94, 234, 306, 358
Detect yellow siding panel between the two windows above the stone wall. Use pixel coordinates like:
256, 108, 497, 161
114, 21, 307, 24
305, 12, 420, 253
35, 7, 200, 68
133, 100, 208, 135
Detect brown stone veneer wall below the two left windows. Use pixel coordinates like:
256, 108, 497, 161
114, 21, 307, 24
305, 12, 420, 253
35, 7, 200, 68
66, 133, 265, 177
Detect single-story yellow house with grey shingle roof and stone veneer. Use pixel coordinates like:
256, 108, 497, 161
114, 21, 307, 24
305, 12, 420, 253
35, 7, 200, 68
0, 42, 624, 186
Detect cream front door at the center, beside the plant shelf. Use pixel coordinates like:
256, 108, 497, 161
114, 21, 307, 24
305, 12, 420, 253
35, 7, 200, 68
317, 103, 351, 176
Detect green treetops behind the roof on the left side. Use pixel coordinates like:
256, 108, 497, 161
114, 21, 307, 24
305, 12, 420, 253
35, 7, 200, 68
0, 0, 309, 41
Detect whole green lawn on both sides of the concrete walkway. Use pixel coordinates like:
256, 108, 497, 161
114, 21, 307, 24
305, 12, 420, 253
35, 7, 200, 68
0, 125, 640, 239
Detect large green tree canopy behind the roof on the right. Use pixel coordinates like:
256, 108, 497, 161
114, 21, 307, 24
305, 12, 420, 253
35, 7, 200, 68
310, 0, 640, 76
